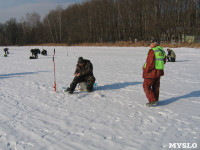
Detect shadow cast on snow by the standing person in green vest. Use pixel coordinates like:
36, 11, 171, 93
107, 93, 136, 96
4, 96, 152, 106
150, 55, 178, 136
158, 91, 200, 106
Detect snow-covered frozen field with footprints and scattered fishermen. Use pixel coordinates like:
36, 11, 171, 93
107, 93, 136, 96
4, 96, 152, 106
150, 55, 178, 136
0, 47, 200, 150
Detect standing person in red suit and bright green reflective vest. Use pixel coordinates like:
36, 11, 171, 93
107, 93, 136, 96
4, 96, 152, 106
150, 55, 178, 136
143, 42, 166, 107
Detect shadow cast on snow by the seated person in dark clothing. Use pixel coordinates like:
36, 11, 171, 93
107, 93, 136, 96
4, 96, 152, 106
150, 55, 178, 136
98, 82, 142, 90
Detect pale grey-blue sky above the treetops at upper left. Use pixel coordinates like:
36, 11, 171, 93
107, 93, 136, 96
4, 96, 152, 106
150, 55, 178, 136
0, 0, 84, 23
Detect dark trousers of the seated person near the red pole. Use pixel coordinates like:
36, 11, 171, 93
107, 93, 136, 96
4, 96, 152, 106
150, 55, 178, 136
70, 75, 95, 92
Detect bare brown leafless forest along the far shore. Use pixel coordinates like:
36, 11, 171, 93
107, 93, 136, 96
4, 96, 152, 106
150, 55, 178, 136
0, 0, 200, 45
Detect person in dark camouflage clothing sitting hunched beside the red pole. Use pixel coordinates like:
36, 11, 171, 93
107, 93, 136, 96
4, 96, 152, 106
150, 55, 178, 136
66, 57, 95, 94
